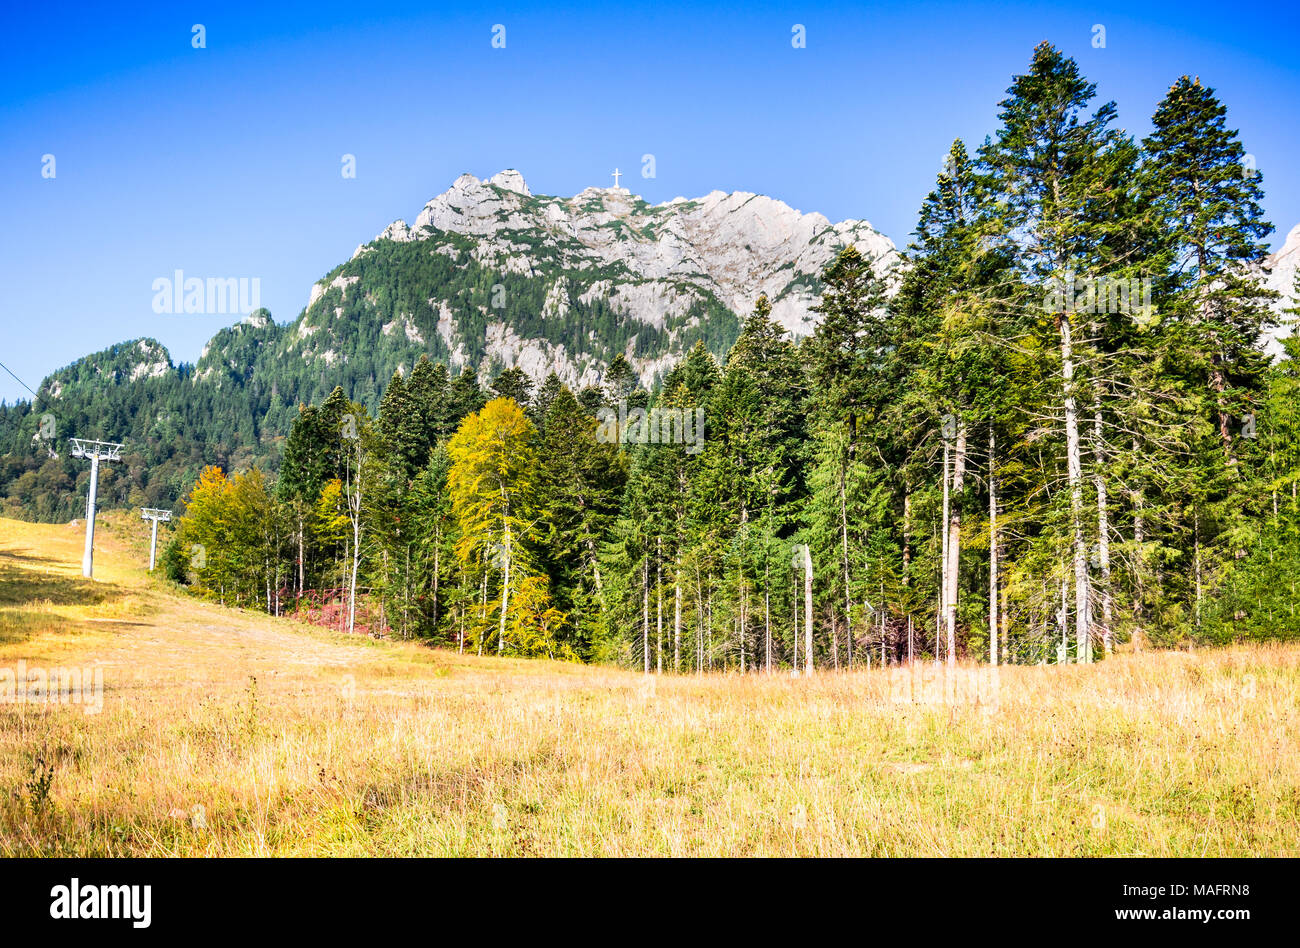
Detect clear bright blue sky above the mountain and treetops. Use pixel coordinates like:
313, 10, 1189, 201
0, 0, 1300, 401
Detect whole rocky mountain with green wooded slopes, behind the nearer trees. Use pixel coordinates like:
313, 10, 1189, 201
0, 170, 898, 520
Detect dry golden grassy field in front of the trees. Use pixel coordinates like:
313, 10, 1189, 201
0, 515, 1300, 856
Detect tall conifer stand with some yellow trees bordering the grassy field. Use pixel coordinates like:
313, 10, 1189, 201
7, 44, 1300, 672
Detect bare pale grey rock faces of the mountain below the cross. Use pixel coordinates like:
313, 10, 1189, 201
314, 169, 898, 386
